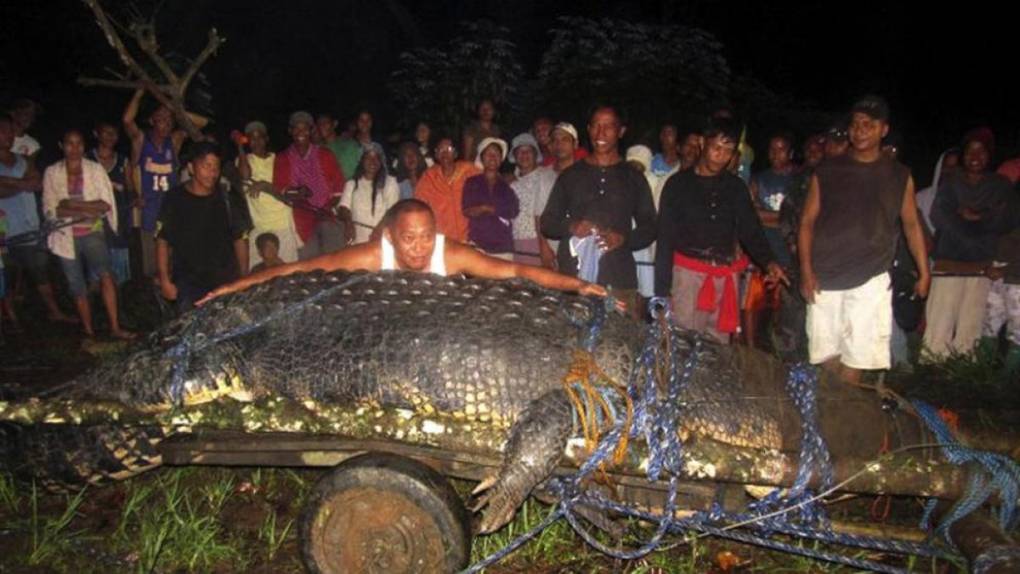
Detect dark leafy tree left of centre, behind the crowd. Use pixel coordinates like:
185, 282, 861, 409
389, 20, 526, 136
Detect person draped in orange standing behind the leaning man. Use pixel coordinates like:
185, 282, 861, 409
414, 138, 479, 243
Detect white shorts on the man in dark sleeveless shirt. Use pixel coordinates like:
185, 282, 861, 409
807, 273, 893, 369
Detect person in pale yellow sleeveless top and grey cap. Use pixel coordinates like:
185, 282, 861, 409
235, 120, 302, 267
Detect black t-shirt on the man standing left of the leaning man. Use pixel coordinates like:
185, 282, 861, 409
156, 184, 251, 291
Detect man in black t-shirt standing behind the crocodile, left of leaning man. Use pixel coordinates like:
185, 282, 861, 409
156, 142, 251, 312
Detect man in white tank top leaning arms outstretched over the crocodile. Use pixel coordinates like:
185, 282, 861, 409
199, 199, 607, 305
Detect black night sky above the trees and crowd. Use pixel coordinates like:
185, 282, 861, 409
0, 0, 1020, 180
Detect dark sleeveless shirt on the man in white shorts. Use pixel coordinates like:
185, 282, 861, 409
811, 155, 910, 291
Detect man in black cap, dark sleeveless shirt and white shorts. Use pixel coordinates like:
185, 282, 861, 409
798, 96, 930, 383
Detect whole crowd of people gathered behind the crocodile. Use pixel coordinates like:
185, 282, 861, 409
0, 91, 1020, 381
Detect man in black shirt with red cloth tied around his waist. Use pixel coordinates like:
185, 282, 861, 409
655, 119, 788, 344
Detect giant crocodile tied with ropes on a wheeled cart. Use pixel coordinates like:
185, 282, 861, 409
0, 271, 954, 531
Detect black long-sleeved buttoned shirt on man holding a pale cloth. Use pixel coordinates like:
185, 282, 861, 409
540, 160, 655, 289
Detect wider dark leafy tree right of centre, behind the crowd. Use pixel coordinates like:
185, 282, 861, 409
536, 16, 730, 134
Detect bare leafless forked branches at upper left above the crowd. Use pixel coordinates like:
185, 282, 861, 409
78, 0, 224, 140
